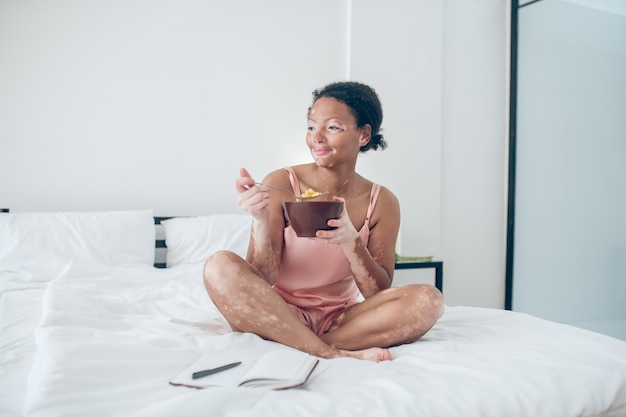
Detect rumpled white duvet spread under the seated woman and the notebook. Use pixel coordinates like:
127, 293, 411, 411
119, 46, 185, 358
14, 265, 626, 417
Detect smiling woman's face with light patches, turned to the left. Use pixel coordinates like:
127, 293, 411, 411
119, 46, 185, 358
306, 97, 371, 167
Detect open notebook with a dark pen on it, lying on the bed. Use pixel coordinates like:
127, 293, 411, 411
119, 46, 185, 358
170, 349, 319, 389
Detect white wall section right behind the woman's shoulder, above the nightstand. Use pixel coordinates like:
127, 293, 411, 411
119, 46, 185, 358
350, 0, 443, 275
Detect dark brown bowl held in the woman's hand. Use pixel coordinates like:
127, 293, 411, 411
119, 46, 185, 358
283, 201, 343, 237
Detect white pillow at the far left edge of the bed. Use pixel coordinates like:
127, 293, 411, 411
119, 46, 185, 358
0, 210, 155, 281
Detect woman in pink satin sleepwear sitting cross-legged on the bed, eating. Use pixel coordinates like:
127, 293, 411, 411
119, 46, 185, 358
204, 82, 443, 361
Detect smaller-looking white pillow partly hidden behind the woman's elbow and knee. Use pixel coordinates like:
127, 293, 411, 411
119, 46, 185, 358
161, 214, 252, 268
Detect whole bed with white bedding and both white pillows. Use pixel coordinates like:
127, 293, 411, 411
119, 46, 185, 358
0, 210, 626, 417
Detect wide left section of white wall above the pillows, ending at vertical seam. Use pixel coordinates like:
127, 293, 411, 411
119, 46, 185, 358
0, 0, 347, 215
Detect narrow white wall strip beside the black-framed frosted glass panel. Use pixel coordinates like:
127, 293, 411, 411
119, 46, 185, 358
441, 0, 510, 307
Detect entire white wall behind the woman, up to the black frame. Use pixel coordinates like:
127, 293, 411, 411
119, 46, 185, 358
0, 0, 509, 307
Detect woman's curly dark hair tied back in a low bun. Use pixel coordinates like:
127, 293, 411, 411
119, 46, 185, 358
309, 81, 387, 152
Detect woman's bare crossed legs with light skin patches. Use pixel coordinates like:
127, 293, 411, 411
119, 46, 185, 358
204, 252, 443, 361
